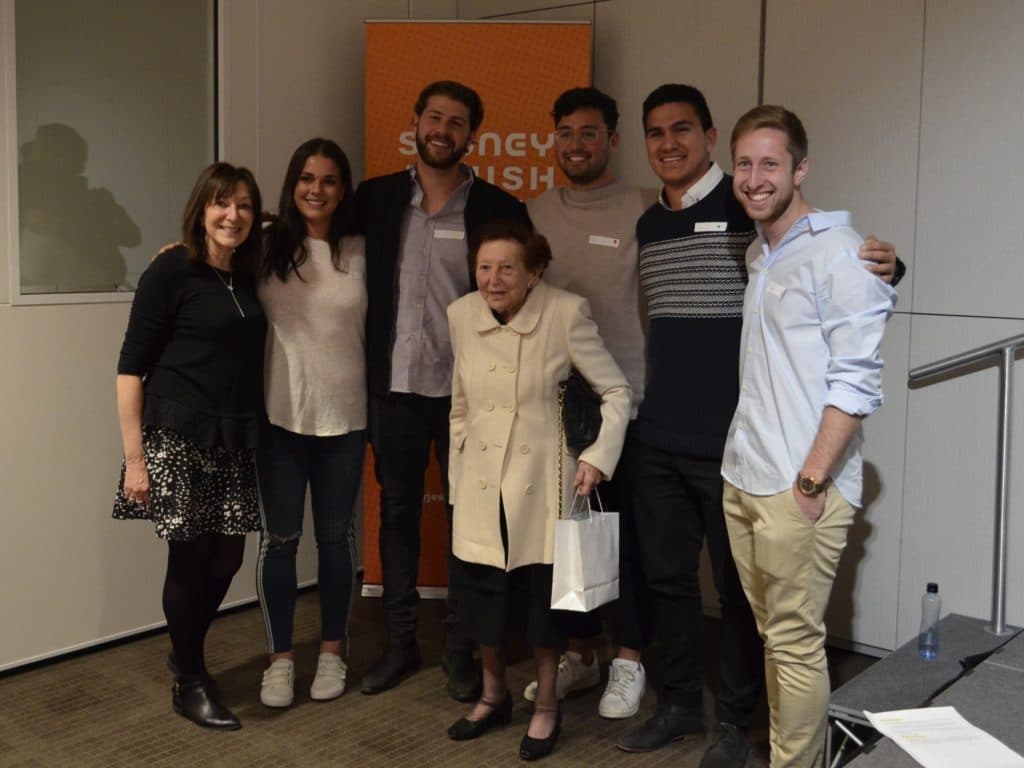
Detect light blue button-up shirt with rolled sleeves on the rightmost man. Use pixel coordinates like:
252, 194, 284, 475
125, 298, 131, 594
722, 211, 896, 507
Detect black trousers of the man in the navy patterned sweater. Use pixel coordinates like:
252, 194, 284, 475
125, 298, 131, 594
632, 443, 764, 727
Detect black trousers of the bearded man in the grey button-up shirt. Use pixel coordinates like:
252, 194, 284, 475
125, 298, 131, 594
370, 392, 470, 650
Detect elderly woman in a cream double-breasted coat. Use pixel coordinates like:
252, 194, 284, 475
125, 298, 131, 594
447, 221, 630, 760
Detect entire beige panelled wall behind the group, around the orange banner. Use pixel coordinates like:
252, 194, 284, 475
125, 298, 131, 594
0, 0, 1024, 669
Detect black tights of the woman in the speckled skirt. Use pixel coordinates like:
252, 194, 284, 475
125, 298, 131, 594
164, 534, 246, 675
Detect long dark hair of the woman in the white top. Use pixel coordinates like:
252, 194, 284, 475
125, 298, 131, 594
260, 138, 355, 282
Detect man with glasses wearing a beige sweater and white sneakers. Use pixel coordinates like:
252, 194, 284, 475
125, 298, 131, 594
523, 88, 654, 719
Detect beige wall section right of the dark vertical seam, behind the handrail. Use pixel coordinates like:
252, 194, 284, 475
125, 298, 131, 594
764, 0, 1024, 648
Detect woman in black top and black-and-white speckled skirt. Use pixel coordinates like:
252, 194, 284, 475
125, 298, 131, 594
114, 163, 266, 729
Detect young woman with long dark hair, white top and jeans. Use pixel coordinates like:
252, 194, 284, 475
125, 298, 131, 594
257, 138, 367, 707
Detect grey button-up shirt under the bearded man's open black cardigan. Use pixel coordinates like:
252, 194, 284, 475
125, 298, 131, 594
391, 166, 473, 397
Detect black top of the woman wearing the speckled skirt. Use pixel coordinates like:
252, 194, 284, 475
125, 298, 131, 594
118, 248, 266, 450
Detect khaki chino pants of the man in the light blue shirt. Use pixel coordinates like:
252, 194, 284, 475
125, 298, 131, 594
723, 482, 855, 768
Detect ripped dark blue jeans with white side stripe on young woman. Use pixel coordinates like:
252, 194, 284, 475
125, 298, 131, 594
256, 425, 366, 653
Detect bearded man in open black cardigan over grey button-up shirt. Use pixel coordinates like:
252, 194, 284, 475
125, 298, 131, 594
355, 81, 528, 701
